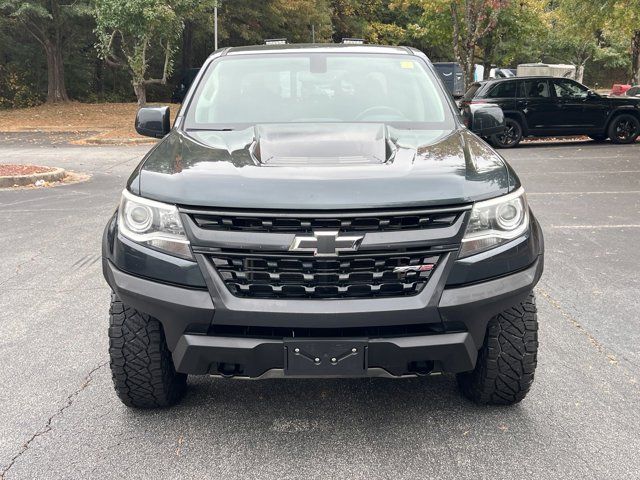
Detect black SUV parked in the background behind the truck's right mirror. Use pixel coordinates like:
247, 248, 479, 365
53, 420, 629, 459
461, 77, 640, 148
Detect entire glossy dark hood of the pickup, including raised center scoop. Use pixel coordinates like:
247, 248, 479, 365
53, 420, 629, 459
128, 124, 519, 210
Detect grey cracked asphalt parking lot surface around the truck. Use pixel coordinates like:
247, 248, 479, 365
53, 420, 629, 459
0, 137, 640, 479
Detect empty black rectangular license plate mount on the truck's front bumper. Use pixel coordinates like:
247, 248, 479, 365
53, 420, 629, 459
284, 338, 367, 377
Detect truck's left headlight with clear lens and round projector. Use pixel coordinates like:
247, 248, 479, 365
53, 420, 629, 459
118, 190, 193, 260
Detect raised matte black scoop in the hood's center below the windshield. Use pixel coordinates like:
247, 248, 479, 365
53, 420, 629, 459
251, 123, 396, 167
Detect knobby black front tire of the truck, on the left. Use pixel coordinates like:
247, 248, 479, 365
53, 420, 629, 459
109, 295, 187, 408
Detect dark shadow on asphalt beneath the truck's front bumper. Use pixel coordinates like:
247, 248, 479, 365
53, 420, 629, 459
130, 375, 529, 446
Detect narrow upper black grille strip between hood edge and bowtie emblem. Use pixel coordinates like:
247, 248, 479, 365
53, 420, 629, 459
193, 212, 460, 233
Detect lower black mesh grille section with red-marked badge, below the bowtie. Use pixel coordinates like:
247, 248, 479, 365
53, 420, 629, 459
210, 252, 440, 298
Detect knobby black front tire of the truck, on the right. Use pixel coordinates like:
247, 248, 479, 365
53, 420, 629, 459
458, 293, 538, 405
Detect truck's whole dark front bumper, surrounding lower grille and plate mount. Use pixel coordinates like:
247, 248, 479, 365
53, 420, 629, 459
103, 206, 544, 378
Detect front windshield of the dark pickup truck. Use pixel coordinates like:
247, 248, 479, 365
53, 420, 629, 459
185, 53, 453, 129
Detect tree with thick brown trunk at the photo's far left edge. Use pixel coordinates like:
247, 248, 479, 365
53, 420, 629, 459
0, 0, 88, 102
